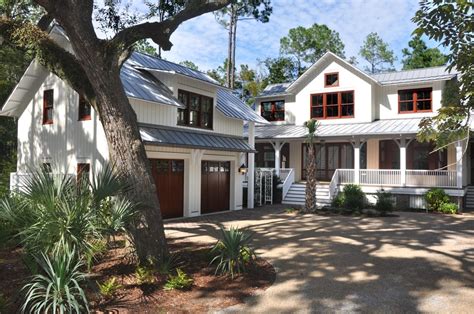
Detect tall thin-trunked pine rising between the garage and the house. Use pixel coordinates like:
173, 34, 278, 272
215, 0, 273, 89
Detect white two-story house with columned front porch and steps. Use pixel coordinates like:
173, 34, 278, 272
251, 52, 474, 207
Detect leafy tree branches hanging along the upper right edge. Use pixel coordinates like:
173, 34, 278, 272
413, 0, 474, 148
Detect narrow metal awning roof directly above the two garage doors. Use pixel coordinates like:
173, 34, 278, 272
140, 125, 255, 152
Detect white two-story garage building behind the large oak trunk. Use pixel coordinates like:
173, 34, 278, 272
0, 27, 266, 218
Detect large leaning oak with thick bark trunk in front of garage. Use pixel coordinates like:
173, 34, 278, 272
0, 0, 231, 261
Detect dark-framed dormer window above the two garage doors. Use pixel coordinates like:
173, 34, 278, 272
178, 90, 214, 129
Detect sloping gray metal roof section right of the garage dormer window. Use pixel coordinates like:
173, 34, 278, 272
216, 88, 269, 124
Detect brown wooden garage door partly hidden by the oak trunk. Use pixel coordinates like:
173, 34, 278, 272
150, 159, 184, 219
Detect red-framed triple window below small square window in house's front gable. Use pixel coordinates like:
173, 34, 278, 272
310, 91, 354, 119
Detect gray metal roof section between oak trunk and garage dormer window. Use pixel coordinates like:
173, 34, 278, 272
120, 62, 184, 107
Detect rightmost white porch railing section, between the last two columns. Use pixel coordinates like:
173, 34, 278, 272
406, 170, 457, 188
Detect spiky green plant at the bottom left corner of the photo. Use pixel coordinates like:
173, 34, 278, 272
22, 249, 89, 313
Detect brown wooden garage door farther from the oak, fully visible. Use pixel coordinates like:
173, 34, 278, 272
201, 161, 230, 214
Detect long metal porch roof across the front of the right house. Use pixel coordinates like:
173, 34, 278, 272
250, 118, 421, 139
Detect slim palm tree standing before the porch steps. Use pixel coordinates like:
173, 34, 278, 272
304, 119, 319, 212
